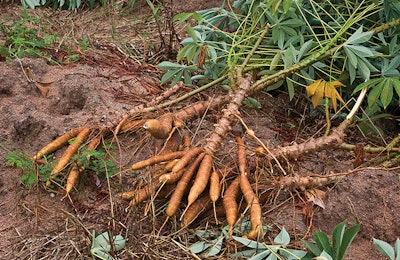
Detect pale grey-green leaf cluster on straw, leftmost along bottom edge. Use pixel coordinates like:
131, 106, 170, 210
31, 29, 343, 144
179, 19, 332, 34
90, 231, 126, 260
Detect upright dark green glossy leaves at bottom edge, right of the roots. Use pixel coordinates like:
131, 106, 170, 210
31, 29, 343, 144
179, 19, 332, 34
303, 221, 361, 260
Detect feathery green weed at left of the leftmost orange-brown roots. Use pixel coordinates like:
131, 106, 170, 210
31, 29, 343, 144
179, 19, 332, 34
3, 147, 53, 188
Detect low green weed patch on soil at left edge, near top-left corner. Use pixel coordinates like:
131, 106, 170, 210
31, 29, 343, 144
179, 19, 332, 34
0, 10, 58, 61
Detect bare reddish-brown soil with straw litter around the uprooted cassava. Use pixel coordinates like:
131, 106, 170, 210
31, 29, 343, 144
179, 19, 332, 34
0, 0, 400, 259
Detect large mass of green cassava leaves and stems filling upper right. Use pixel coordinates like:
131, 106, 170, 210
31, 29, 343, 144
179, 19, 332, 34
159, 0, 400, 122
